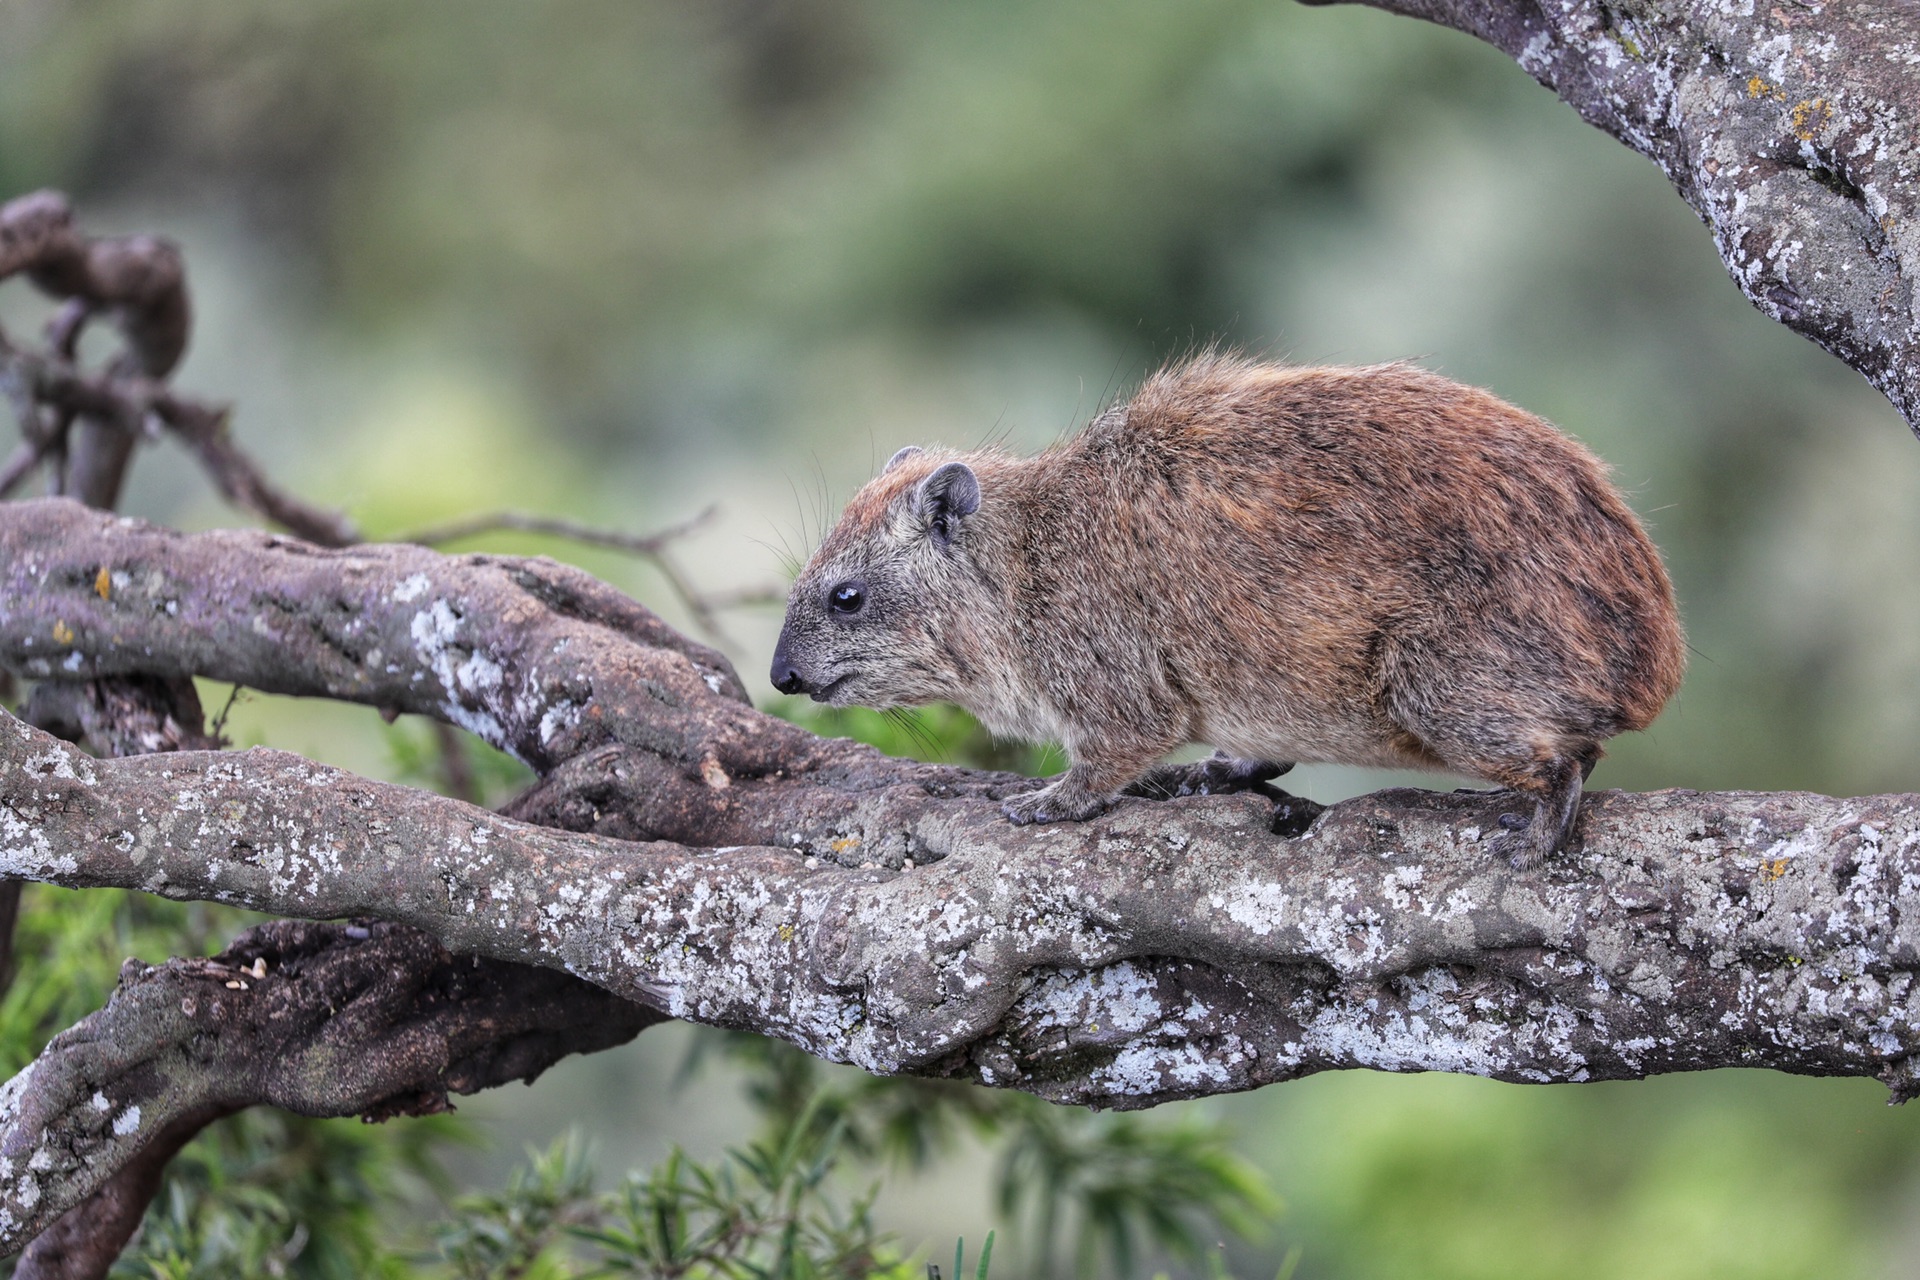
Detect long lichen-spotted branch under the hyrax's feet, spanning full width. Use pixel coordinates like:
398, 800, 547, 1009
0, 671, 1920, 1128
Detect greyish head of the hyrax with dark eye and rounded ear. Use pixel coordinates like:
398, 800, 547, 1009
772, 447, 985, 708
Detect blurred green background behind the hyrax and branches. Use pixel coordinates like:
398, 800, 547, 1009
0, 0, 1920, 1280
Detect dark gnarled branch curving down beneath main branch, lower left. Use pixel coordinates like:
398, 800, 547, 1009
0, 921, 660, 1276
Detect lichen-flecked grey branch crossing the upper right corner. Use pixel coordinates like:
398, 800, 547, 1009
1309, 0, 1920, 432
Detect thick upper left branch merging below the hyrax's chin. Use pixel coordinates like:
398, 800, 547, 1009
0, 501, 960, 864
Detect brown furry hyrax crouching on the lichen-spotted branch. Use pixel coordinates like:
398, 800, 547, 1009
774, 353, 1684, 867
